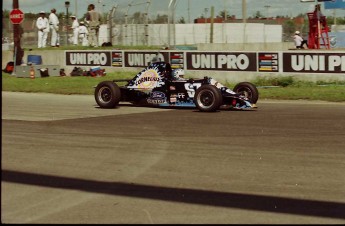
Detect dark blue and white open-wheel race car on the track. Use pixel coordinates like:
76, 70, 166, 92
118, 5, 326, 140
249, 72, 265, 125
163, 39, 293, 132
94, 62, 259, 112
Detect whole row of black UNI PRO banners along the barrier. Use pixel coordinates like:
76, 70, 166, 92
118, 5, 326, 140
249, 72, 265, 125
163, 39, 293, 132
65, 50, 345, 75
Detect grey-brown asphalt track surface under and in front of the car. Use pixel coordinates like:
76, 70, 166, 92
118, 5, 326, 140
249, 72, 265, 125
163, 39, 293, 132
1, 92, 345, 224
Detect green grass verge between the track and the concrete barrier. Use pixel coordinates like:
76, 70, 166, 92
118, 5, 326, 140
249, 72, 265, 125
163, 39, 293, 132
2, 71, 345, 102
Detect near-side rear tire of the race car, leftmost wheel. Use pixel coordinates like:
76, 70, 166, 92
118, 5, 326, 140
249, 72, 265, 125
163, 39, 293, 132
95, 81, 121, 108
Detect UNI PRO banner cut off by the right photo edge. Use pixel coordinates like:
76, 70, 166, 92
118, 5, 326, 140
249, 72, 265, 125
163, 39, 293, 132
283, 53, 345, 73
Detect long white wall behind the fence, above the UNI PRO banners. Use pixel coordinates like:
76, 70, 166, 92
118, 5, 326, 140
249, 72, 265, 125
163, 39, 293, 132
107, 23, 283, 46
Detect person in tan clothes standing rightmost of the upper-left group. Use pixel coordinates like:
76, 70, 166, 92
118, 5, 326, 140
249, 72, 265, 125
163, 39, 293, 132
86, 4, 101, 47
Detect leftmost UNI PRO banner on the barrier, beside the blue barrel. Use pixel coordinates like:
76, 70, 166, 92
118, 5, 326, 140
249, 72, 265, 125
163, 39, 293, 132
65, 51, 112, 66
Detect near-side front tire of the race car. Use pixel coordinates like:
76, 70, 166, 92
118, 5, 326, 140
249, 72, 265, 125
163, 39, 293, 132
194, 85, 223, 112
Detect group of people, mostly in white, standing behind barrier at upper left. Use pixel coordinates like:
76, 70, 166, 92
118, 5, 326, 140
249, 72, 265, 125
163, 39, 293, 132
36, 4, 101, 48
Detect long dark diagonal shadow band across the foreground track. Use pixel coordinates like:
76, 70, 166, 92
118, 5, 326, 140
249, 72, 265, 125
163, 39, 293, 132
2, 170, 345, 219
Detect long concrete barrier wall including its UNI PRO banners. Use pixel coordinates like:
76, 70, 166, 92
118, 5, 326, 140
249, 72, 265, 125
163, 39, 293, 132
2, 47, 345, 83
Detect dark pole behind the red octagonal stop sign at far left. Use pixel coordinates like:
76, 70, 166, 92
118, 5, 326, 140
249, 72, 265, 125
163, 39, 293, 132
13, 0, 24, 65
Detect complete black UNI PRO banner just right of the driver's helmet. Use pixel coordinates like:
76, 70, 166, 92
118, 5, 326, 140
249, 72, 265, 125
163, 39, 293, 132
186, 52, 257, 71
